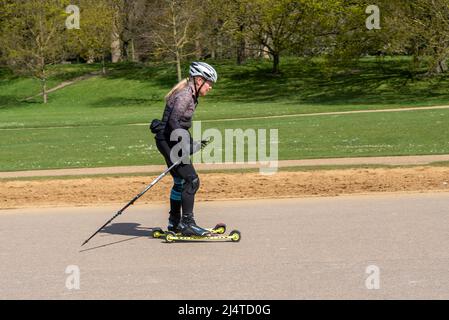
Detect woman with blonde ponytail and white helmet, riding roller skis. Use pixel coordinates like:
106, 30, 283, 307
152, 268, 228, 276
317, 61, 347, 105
156, 62, 218, 236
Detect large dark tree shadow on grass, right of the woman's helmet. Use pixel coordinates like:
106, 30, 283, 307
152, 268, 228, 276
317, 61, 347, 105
213, 59, 449, 105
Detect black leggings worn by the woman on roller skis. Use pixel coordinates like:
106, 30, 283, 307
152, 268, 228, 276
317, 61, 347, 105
156, 139, 200, 215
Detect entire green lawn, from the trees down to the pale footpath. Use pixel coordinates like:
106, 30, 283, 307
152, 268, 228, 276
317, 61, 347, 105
0, 58, 449, 171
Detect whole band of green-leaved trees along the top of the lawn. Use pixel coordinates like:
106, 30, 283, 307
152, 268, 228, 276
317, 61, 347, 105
0, 0, 449, 79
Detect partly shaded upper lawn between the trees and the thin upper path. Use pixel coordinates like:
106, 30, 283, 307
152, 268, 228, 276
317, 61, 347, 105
0, 58, 449, 128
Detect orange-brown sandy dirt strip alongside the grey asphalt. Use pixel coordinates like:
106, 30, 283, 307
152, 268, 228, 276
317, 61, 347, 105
0, 166, 449, 209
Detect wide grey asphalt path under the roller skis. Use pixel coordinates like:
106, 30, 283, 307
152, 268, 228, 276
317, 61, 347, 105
0, 193, 449, 299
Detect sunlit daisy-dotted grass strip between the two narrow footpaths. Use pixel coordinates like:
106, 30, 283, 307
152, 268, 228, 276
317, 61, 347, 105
0, 110, 449, 171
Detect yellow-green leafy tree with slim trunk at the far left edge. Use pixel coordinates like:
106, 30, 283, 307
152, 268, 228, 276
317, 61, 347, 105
1, 0, 69, 103
